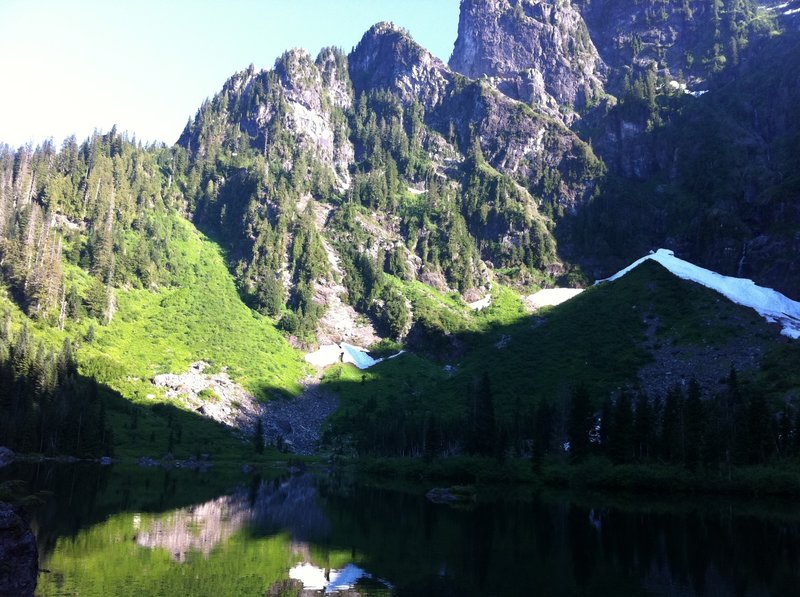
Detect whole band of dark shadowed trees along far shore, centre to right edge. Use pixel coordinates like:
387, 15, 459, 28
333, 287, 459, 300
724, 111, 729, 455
332, 369, 800, 471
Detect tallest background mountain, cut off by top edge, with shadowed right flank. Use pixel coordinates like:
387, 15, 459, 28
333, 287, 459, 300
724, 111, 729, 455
450, 0, 800, 296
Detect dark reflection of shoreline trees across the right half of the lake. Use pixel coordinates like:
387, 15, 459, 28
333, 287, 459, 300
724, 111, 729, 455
323, 488, 800, 596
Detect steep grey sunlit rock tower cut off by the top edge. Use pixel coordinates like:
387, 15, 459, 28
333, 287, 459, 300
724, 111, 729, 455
450, 0, 605, 114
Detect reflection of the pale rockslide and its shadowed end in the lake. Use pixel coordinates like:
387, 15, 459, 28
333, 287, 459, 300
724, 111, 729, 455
136, 475, 329, 562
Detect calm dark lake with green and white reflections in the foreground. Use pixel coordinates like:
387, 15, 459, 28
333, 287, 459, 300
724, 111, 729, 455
4, 465, 800, 597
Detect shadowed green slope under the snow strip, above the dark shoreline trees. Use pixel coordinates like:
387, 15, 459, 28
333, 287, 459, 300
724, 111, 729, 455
324, 262, 800, 452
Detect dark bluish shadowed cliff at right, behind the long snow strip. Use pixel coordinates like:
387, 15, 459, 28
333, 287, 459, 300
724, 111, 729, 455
565, 31, 800, 298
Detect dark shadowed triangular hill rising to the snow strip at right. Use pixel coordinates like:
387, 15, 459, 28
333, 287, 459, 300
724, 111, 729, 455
324, 255, 800, 458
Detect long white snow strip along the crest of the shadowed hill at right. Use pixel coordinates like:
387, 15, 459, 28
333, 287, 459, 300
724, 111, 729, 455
595, 249, 800, 339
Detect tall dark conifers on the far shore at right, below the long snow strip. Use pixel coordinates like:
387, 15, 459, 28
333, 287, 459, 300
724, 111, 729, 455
556, 369, 800, 470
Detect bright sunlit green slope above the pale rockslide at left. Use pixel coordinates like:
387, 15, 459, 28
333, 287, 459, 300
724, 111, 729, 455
81, 221, 306, 398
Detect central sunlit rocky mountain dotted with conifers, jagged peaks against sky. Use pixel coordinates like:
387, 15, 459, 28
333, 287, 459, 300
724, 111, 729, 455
178, 23, 602, 344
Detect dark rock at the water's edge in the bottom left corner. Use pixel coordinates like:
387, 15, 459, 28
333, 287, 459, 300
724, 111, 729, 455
0, 502, 39, 597
